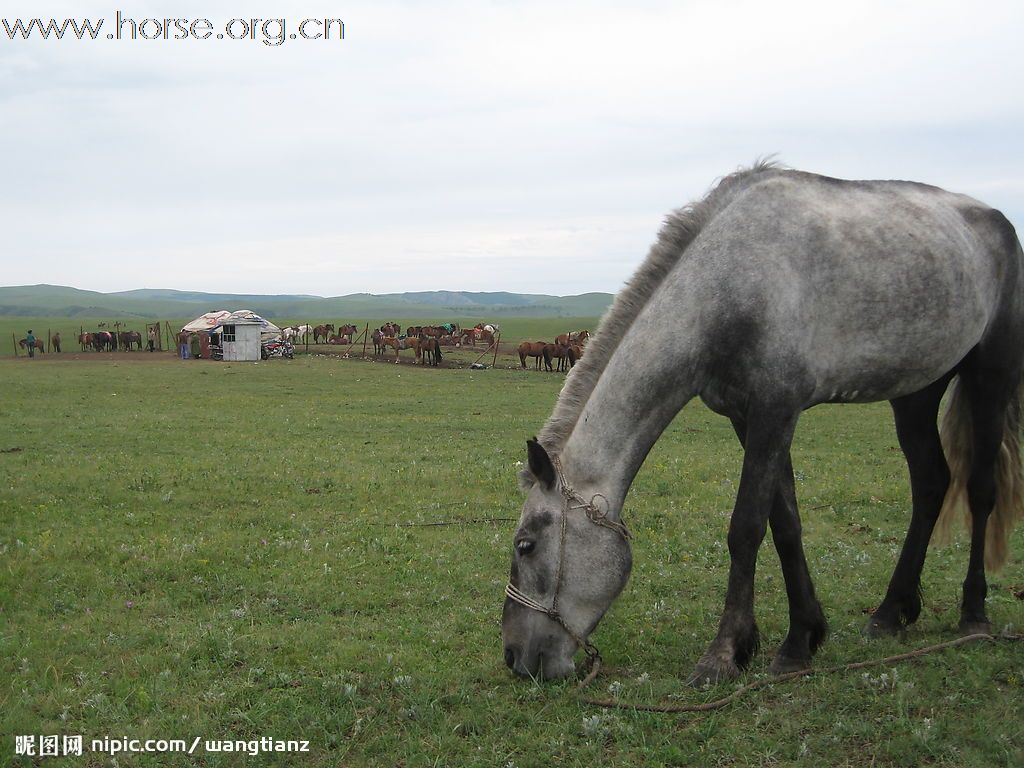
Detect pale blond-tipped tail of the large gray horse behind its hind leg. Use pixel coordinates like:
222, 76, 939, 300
935, 377, 1024, 571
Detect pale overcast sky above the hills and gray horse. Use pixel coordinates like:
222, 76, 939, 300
0, 0, 1024, 296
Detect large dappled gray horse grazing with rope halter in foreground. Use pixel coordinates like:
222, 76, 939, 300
502, 164, 1024, 684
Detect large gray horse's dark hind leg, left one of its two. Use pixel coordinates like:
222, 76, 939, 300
865, 373, 952, 636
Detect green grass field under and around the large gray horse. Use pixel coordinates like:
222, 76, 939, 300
0, 346, 1024, 766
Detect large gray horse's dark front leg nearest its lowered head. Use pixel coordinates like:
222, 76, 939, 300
688, 407, 800, 685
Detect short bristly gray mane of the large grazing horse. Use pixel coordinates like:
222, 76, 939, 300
521, 160, 779, 485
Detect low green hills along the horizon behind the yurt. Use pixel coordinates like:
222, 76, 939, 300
0, 285, 612, 319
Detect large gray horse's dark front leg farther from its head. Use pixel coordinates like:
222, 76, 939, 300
732, 419, 828, 675
